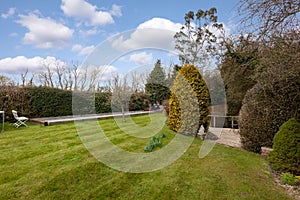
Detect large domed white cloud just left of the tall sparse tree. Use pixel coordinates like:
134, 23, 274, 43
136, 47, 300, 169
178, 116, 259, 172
112, 18, 182, 50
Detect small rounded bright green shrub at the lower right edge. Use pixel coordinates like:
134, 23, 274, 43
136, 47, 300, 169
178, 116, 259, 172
269, 119, 300, 175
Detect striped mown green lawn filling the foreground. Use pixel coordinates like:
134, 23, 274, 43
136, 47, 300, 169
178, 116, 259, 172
0, 114, 290, 200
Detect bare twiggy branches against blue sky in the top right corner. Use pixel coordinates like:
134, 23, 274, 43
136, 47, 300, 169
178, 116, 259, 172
238, 0, 300, 37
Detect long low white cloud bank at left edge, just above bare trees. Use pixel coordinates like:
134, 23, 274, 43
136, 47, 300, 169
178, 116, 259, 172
0, 56, 66, 74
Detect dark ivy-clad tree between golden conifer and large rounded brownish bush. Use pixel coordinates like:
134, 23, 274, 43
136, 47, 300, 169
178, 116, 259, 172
220, 35, 259, 116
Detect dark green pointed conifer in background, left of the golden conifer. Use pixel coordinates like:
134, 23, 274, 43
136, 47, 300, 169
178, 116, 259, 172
145, 60, 170, 104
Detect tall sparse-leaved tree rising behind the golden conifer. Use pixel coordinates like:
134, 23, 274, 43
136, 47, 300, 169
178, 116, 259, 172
174, 8, 224, 72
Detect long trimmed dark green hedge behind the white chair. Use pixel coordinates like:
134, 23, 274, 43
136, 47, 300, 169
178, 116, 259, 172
0, 86, 149, 121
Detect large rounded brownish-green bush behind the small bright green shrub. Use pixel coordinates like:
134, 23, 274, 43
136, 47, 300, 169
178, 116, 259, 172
239, 67, 300, 153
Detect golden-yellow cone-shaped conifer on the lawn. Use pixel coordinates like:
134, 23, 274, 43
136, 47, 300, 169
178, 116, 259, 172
168, 65, 210, 135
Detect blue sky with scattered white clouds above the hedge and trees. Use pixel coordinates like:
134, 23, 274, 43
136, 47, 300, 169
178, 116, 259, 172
0, 0, 238, 82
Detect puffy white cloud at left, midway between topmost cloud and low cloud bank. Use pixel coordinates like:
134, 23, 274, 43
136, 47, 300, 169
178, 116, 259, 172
17, 13, 74, 49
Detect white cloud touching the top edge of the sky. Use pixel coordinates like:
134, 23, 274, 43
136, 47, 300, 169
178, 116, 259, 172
61, 0, 122, 26
